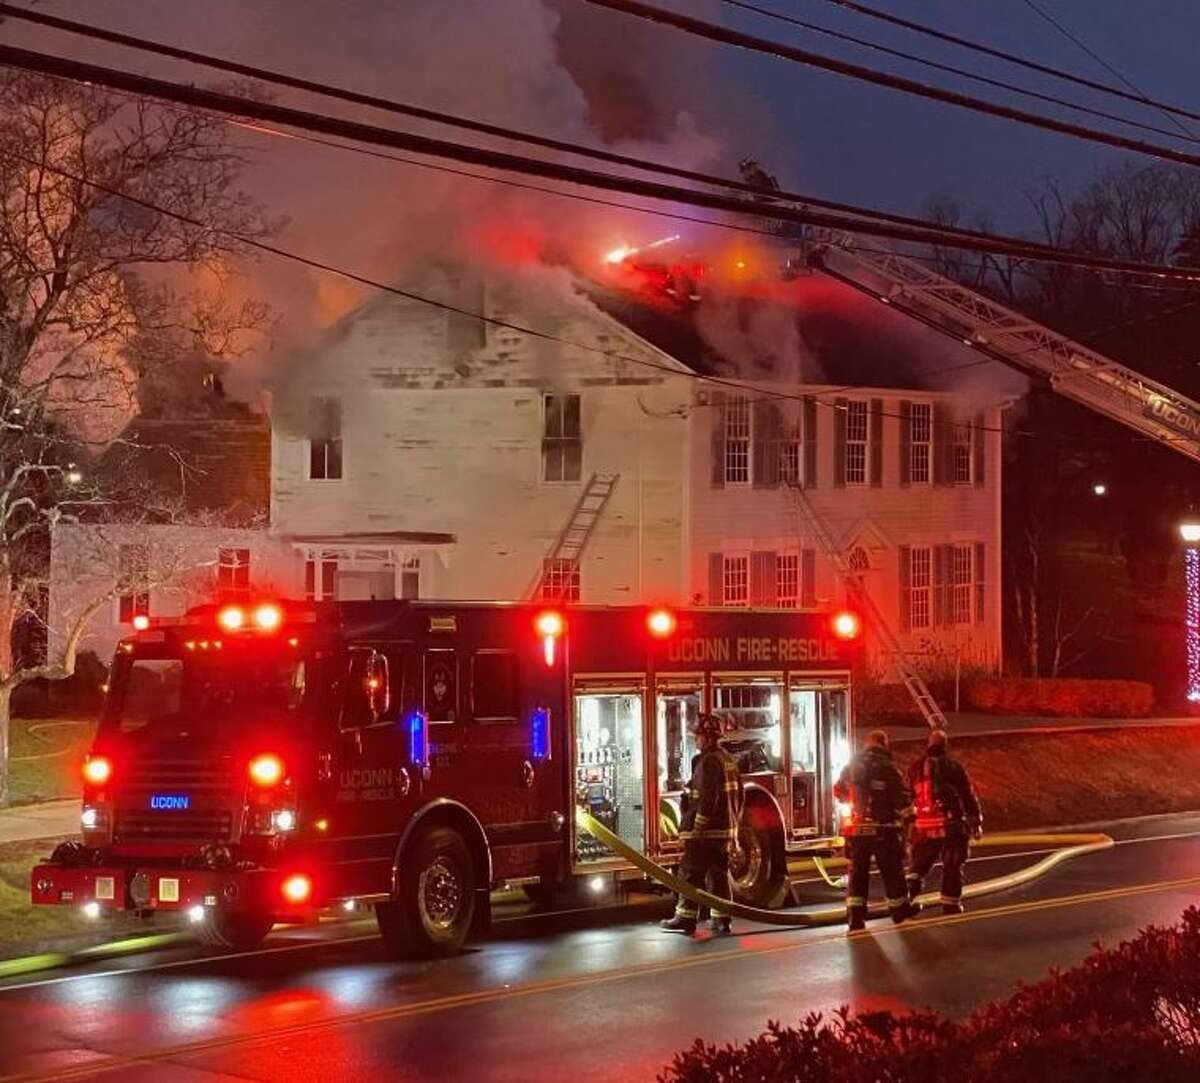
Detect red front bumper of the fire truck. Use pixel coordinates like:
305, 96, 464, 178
30, 864, 280, 911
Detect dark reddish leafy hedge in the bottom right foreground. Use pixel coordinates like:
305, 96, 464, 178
658, 907, 1200, 1083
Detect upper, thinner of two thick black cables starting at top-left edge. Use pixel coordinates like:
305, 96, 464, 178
0, 2, 1176, 276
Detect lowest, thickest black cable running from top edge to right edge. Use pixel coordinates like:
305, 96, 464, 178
583, 0, 1200, 166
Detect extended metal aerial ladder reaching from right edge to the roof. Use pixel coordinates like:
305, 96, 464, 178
809, 233, 1200, 461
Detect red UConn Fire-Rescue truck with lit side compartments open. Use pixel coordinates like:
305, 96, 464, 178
31, 602, 859, 955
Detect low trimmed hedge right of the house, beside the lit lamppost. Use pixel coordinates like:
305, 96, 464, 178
962, 677, 1154, 718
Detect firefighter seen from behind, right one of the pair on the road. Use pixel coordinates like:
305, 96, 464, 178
907, 730, 983, 914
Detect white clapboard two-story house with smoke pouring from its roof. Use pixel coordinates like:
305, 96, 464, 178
55, 260, 1001, 686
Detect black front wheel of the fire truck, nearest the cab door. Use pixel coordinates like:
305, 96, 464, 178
376, 827, 475, 958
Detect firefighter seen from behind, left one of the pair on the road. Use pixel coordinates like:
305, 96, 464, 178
833, 730, 914, 933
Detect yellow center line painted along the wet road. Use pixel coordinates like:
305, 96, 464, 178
9, 876, 1200, 1083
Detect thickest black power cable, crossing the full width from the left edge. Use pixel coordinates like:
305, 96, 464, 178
7, 46, 1200, 283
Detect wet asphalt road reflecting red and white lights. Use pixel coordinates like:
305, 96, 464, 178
0, 816, 1200, 1083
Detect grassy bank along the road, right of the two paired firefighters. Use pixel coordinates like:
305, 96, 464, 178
894, 724, 1200, 831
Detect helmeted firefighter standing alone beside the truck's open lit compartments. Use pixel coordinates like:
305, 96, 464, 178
661, 714, 743, 937
